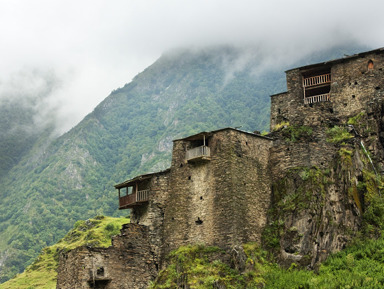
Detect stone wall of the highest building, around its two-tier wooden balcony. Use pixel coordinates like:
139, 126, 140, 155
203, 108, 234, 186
271, 51, 384, 130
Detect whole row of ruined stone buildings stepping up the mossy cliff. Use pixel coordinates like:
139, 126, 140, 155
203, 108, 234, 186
57, 49, 384, 289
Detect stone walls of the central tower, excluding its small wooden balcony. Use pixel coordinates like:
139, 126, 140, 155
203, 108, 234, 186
164, 129, 272, 254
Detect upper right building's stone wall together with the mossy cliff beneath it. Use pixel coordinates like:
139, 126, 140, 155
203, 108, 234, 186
265, 50, 384, 267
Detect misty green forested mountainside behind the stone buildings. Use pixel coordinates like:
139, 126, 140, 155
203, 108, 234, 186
0, 47, 368, 282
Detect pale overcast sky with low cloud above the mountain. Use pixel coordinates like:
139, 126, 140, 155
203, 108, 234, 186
0, 0, 384, 130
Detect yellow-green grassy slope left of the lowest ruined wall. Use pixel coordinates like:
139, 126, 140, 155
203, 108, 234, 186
0, 216, 129, 289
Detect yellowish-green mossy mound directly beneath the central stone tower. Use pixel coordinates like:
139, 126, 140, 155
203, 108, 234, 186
150, 243, 266, 289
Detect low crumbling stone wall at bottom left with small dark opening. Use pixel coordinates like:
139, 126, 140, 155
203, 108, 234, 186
56, 224, 157, 289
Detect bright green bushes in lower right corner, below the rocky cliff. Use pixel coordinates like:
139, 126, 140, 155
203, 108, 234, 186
264, 226, 384, 289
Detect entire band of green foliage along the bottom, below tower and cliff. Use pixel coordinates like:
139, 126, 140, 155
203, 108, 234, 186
150, 237, 384, 289
